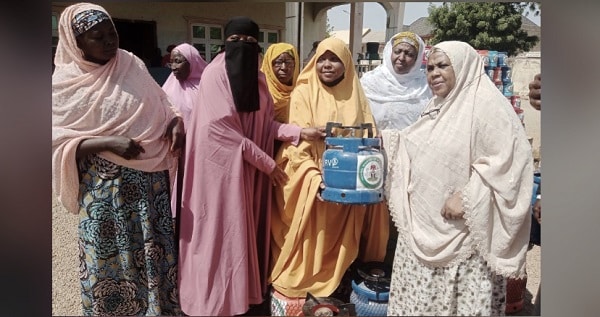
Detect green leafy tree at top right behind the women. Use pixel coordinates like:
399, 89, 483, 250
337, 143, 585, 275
429, 2, 539, 56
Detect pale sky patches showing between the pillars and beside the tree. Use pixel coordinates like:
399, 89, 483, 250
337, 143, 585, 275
327, 2, 541, 31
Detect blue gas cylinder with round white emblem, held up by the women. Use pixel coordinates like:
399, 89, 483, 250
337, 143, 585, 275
321, 122, 385, 204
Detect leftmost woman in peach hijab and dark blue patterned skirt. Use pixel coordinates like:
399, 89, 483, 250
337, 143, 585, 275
52, 3, 184, 316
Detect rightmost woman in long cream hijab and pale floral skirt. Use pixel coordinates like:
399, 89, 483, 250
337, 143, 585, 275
381, 41, 533, 316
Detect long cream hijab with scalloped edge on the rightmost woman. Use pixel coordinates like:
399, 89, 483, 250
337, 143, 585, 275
382, 41, 533, 277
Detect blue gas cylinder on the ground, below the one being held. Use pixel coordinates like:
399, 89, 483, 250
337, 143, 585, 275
350, 262, 391, 316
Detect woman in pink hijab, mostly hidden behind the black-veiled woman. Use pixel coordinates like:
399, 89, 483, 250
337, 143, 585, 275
162, 43, 208, 236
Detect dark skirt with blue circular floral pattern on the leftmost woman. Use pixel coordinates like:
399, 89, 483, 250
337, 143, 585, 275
79, 155, 181, 316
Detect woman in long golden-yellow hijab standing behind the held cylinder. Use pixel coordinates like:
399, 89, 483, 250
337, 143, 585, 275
270, 38, 389, 315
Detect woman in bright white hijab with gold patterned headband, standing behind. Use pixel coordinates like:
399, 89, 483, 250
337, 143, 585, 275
360, 32, 432, 130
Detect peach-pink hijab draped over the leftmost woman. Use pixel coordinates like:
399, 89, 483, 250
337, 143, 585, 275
52, 3, 176, 213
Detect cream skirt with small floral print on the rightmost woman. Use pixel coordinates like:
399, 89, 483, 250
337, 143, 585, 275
387, 238, 506, 316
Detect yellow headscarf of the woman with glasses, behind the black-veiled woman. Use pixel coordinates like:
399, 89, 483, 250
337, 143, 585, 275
260, 43, 300, 123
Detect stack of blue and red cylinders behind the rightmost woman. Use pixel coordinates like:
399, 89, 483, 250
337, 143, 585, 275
478, 50, 524, 123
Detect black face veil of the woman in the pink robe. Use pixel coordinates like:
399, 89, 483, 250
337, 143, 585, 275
225, 17, 260, 112
